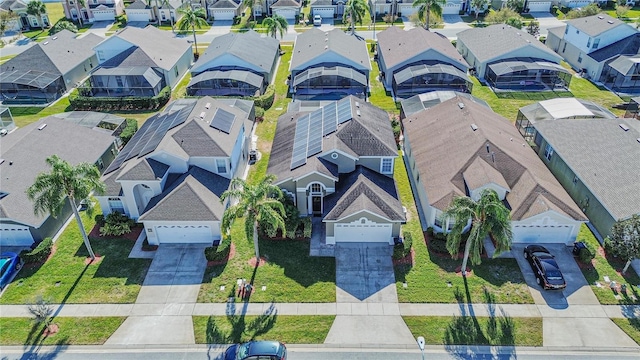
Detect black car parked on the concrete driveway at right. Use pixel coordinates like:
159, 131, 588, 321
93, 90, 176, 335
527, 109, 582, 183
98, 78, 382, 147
524, 245, 567, 290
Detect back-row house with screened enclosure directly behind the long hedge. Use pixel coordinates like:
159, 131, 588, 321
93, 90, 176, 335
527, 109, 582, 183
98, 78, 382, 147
89, 26, 193, 97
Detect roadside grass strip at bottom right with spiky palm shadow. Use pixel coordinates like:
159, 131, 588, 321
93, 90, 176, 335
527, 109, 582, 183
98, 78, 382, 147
403, 312, 542, 346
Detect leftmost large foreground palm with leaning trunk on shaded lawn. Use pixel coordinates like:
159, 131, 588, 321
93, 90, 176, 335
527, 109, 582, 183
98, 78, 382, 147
27, 155, 106, 260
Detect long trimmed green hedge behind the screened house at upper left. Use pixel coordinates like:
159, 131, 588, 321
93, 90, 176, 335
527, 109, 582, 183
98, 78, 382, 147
69, 86, 171, 111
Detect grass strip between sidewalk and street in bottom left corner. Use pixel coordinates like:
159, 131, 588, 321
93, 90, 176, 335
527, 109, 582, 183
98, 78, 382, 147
0, 317, 125, 344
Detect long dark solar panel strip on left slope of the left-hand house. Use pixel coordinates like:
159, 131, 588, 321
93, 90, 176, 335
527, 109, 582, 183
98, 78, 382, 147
104, 103, 195, 174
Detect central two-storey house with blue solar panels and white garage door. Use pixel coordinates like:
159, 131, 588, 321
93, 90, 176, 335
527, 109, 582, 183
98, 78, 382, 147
267, 96, 405, 245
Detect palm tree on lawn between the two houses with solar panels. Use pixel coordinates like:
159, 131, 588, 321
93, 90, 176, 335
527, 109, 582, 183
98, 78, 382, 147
220, 175, 286, 263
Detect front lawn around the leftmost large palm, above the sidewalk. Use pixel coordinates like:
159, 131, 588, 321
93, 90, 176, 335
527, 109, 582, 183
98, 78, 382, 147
0, 207, 151, 304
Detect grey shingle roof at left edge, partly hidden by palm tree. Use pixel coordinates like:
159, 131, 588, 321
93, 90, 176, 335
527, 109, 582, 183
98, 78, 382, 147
0, 118, 115, 227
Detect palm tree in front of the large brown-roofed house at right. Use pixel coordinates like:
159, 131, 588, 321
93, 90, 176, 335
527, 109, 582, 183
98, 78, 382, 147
442, 189, 513, 275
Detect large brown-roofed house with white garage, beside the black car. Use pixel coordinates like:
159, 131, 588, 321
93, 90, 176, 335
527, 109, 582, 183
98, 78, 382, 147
402, 96, 587, 245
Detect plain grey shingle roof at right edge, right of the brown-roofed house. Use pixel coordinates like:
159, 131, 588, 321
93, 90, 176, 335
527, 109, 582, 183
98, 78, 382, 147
534, 119, 640, 219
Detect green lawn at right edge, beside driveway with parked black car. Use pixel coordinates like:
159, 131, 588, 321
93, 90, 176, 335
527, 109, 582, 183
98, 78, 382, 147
577, 225, 640, 304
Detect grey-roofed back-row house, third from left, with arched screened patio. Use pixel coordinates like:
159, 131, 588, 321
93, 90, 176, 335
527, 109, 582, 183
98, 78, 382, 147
187, 30, 280, 96
